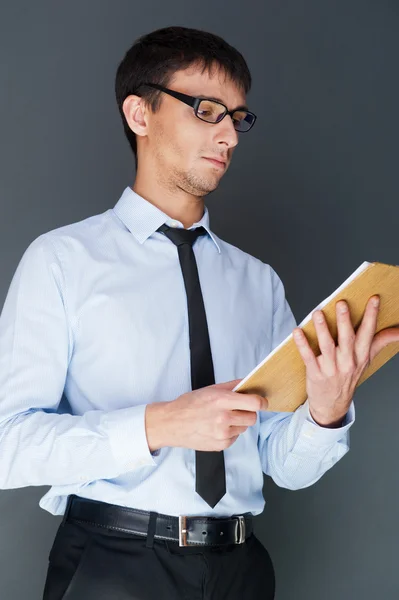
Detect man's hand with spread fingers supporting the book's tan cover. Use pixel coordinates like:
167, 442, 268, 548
293, 296, 399, 427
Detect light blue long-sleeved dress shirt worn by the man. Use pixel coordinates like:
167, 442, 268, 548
0, 187, 355, 516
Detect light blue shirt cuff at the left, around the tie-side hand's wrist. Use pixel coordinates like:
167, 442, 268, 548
106, 404, 159, 473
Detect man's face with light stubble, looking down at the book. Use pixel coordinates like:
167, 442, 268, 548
145, 67, 246, 196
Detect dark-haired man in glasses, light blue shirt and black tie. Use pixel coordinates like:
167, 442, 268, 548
0, 27, 397, 600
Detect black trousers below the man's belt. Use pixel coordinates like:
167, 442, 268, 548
43, 520, 275, 600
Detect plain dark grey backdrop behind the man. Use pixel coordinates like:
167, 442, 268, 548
0, 0, 399, 600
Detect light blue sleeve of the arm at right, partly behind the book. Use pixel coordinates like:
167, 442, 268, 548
258, 268, 355, 490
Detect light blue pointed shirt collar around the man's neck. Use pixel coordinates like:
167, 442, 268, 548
113, 186, 220, 254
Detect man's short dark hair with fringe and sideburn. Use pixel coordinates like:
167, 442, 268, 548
115, 27, 251, 168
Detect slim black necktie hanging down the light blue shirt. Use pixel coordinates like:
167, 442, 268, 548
158, 224, 226, 508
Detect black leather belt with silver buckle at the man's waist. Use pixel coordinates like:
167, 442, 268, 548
62, 494, 253, 546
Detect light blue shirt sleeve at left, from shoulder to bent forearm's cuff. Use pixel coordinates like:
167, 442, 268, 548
0, 234, 157, 489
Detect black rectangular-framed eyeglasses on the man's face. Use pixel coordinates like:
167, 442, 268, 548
143, 83, 256, 133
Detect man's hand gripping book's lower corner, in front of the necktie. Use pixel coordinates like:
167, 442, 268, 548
145, 379, 268, 452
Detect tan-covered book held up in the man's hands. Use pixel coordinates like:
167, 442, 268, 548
233, 261, 399, 412
